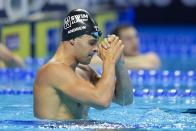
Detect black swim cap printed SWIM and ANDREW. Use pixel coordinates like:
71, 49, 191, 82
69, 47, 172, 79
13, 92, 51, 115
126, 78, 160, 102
62, 9, 101, 41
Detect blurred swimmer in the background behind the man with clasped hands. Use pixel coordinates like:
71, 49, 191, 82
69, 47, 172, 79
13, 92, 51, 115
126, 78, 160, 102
91, 25, 160, 70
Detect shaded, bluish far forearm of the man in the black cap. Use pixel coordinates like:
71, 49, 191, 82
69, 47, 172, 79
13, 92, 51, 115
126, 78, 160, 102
113, 56, 133, 106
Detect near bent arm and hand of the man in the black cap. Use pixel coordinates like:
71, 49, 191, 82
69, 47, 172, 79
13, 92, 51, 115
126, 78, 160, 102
48, 37, 124, 109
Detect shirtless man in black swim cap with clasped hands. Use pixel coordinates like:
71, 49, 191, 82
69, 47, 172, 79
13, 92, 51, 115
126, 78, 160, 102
34, 9, 133, 120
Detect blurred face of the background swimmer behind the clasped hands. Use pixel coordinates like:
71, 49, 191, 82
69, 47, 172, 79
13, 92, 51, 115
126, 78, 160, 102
119, 27, 139, 56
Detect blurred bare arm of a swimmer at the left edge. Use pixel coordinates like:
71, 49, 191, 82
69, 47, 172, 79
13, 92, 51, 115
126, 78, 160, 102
0, 43, 24, 68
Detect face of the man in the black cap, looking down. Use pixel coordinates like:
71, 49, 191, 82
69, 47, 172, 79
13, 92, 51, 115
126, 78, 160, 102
74, 35, 98, 64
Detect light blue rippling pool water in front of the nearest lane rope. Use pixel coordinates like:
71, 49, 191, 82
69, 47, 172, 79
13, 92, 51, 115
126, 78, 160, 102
0, 94, 196, 130
